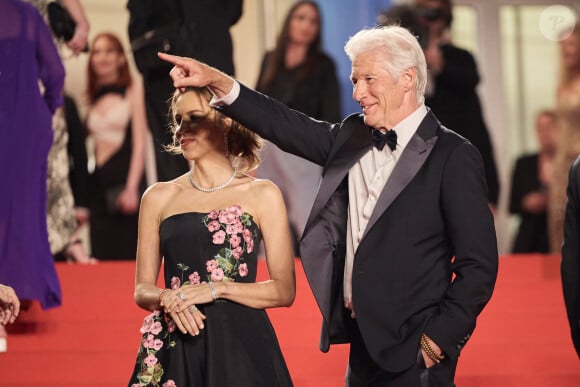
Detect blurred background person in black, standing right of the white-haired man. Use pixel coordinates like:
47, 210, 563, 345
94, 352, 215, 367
509, 110, 558, 254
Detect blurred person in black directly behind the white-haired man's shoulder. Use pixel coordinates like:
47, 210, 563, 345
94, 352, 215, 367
415, 0, 500, 209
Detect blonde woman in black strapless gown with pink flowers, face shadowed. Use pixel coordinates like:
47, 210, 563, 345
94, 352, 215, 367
129, 88, 296, 387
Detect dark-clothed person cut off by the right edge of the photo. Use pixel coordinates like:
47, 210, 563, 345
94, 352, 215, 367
560, 156, 580, 358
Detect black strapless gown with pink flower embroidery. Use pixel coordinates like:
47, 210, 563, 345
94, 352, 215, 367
129, 206, 293, 387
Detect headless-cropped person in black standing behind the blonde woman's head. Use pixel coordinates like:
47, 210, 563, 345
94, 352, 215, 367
127, 0, 244, 181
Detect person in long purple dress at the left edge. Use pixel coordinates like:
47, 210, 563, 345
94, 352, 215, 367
0, 0, 65, 348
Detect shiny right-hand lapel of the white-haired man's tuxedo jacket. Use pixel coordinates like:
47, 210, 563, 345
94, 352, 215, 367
361, 112, 440, 243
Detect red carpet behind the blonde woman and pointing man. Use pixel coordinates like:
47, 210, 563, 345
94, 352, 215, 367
0, 256, 580, 387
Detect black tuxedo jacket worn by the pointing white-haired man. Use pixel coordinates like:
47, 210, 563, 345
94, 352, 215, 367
221, 86, 498, 371
